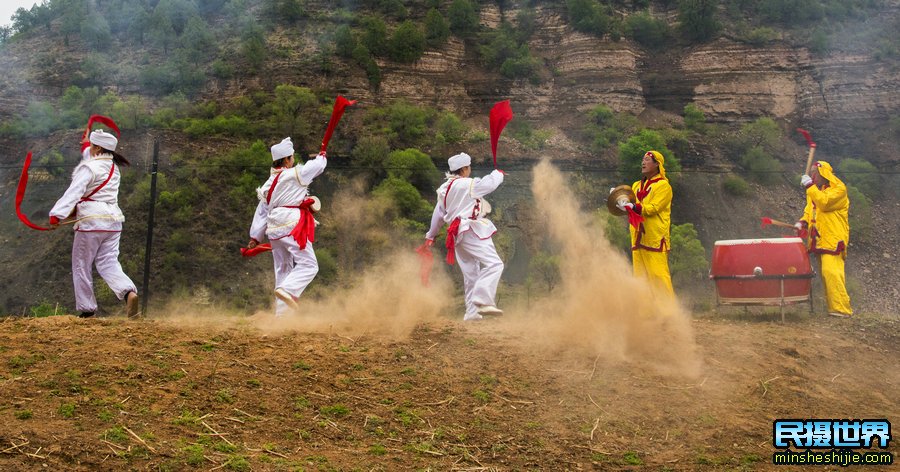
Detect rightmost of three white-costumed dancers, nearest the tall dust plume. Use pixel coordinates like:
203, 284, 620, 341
425, 153, 503, 321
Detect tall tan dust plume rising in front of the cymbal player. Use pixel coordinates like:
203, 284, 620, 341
504, 160, 700, 377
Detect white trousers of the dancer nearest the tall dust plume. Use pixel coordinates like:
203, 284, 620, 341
456, 231, 503, 318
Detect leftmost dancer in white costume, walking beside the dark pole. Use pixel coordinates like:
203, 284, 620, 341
50, 130, 138, 318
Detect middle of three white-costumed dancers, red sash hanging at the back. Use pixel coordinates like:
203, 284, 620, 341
247, 138, 327, 316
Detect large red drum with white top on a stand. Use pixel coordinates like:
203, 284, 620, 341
709, 238, 815, 316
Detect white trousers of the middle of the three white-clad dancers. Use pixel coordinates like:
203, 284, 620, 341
270, 235, 319, 316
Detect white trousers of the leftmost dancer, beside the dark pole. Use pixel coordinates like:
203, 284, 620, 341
72, 231, 137, 312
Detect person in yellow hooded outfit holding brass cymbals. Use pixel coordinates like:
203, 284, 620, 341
620, 151, 675, 297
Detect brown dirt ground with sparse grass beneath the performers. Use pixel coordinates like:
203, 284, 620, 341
0, 310, 900, 470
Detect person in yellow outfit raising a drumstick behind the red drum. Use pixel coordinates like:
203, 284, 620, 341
796, 161, 853, 318
